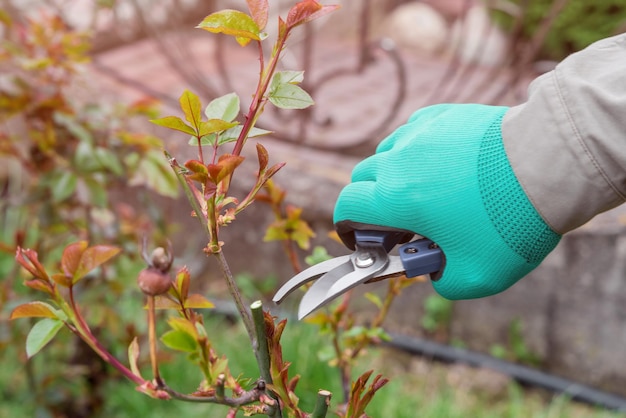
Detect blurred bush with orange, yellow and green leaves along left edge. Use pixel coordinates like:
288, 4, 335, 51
0, 11, 177, 417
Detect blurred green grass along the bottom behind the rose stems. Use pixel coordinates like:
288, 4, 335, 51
0, 321, 625, 418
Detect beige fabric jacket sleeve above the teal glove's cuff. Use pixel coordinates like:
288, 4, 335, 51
502, 34, 626, 233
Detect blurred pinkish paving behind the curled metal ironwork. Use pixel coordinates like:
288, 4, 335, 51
90, 30, 523, 153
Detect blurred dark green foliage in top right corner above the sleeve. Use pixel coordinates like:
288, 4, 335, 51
494, 0, 626, 61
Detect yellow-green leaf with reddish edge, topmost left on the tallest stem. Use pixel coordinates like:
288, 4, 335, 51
196, 9, 261, 46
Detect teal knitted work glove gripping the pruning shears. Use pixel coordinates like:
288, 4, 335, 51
334, 104, 560, 299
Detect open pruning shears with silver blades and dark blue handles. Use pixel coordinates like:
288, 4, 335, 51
273, 230, 443, 319
